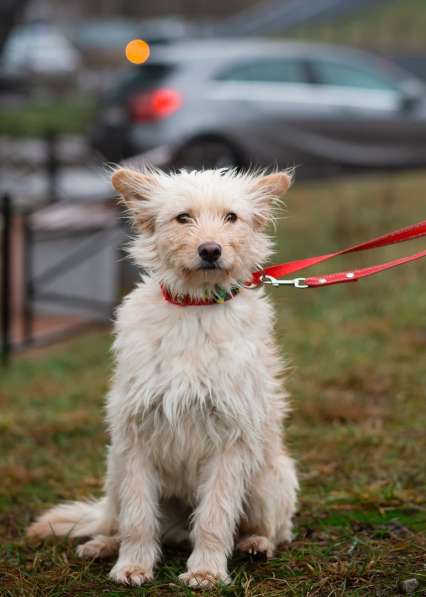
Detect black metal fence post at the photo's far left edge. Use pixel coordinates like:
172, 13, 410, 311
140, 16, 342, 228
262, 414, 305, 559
0, 194, 12, 366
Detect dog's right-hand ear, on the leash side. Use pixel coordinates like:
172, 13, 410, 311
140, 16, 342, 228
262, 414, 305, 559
254, 171, 293, 229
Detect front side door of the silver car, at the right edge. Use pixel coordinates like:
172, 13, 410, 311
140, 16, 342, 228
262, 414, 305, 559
302, 57, 426, 167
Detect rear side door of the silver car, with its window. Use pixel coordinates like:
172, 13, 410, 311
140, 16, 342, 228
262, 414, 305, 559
209, 55, 326, 165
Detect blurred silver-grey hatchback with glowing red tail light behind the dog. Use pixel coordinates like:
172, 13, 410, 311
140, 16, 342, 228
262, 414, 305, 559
91, 39, 426, 175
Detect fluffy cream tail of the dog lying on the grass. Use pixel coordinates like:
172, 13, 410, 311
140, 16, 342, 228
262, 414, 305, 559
27, 497, 114, 539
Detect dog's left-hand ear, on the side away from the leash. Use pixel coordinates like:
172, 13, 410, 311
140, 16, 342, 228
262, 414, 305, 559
111, 168, 156, 231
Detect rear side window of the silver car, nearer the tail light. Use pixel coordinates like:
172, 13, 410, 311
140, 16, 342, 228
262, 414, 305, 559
216, 59, 307, 83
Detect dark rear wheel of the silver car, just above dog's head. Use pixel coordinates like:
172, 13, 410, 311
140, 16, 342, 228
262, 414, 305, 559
174, 138, 242, 169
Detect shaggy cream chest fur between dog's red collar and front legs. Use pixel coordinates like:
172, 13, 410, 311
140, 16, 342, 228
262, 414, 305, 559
111, 286, 273, 443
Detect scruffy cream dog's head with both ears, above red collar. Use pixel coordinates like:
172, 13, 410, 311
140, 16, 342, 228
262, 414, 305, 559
112, 168, 291, 296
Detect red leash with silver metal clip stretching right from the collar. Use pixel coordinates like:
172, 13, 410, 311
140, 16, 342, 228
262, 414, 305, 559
248, 220, 426, 288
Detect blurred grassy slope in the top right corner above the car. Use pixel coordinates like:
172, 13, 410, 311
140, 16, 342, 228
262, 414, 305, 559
290, 0, 426, 51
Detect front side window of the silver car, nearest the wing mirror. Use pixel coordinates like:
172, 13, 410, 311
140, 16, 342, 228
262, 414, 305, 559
312, 60, 398, 91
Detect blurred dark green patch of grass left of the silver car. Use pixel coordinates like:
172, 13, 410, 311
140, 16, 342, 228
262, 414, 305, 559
0, 97, 95, 137
